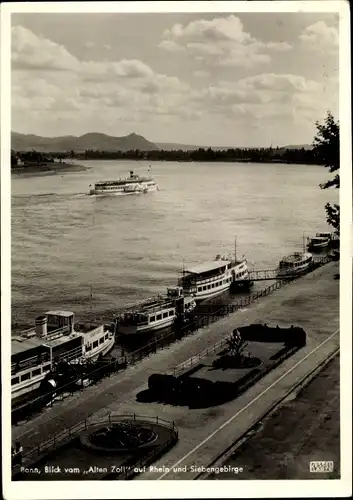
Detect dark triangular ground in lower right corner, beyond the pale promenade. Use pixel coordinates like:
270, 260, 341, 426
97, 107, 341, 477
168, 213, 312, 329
207, 356, 340, 480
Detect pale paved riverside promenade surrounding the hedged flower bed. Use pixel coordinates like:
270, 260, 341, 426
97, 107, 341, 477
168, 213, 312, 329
13, 263, 339, 479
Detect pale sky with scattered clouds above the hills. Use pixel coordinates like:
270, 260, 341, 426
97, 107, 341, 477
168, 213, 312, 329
11, 12, 339, 147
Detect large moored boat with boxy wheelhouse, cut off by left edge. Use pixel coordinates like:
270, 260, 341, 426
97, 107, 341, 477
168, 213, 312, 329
11, 311, 115, 404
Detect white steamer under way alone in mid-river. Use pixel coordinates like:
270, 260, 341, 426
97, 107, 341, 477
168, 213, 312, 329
90, 170, 159, 195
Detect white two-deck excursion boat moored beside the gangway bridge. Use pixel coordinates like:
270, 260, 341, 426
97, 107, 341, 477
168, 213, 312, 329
179, 243, 251, 301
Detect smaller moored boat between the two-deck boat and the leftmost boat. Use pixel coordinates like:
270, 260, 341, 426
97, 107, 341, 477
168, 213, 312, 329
116, 286, 196, 335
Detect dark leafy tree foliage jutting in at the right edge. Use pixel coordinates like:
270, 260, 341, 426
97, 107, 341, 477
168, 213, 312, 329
312, 111, 340, 235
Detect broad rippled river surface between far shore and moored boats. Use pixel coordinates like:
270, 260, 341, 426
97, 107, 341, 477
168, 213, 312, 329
11, 161, 338, 326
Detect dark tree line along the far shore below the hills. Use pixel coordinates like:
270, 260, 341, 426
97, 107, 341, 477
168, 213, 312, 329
11, 148, 322, 167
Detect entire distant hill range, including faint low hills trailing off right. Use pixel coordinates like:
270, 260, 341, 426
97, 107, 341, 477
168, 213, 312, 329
11, 132, 312, 153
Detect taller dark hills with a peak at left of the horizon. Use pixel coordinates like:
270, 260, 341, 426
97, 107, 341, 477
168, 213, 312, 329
11, 132, 159, 153
